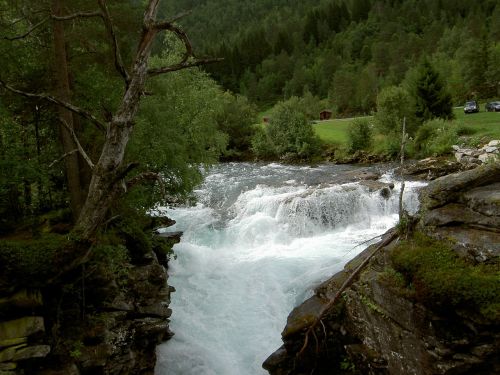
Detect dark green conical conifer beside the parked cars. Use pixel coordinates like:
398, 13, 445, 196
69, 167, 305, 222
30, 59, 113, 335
413, 59, 453, 122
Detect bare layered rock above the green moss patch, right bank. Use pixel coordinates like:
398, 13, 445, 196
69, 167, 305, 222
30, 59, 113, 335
421, 163, 500, 262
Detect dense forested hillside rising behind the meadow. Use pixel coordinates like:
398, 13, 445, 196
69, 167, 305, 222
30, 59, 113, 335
167, 0, 500, 114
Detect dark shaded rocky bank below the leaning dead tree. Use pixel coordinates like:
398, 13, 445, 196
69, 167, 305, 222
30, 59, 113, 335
0, 217, 180, 375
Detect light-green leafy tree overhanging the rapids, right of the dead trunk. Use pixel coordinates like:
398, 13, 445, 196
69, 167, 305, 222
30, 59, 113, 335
126, 66, 228, 207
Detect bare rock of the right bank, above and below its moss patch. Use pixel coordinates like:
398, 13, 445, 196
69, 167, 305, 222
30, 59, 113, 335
263, 163, 500, 375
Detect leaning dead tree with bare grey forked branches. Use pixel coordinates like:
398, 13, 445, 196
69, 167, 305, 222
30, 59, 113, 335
0, 0, 221, 276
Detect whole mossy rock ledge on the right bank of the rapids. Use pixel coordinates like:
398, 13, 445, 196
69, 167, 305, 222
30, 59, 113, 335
263, 163, 500, 375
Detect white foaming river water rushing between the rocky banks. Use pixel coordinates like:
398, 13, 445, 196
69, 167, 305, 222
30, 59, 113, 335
156, 163, 424, 375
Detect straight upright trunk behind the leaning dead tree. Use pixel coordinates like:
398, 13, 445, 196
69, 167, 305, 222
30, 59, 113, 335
52, 0, 82, 219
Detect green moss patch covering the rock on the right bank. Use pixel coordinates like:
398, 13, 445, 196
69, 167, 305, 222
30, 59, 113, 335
392, 234, 500, 321
